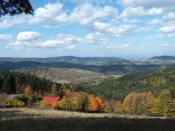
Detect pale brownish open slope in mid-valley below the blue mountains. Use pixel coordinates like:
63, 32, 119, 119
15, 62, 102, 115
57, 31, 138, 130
16, 68, 103, 83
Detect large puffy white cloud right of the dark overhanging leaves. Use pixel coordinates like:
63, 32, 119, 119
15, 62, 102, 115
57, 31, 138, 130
28, 2, 118, 26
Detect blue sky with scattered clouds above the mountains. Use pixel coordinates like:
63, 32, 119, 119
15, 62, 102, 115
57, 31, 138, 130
0, 0, 175, 59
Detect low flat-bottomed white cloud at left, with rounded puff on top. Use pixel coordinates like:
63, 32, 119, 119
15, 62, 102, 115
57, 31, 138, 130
8, 31, 81, 49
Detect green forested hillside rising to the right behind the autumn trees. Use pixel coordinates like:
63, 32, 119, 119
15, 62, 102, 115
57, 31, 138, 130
77, 66, 175, 100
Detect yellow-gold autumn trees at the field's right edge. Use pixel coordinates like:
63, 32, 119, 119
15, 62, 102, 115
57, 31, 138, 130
115, 90, 175, 117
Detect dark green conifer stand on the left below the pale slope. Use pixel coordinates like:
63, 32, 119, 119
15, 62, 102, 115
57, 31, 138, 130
0, 71, 62, 94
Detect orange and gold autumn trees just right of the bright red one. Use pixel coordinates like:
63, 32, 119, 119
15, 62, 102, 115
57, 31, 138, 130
41, 91, 106, 112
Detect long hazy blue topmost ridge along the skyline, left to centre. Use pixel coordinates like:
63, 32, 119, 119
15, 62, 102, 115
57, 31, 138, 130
0, 56, 127, 65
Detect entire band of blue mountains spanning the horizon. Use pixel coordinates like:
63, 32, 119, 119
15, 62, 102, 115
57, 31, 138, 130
0, 56, 175, 74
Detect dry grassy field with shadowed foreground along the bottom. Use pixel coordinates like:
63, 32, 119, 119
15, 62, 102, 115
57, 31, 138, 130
0, 108, 175, 131
